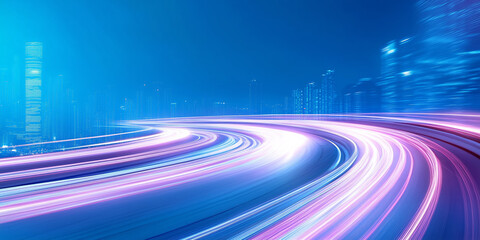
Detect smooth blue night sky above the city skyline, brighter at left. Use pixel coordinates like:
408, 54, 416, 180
0, 0, 418, 102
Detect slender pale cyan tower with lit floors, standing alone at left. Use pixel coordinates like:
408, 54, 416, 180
25, 42, 43, 143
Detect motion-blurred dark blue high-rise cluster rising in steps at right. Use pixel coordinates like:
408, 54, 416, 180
343, 0, 480, 112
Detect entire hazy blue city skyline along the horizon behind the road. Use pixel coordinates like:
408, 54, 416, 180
0, 0, 480, 150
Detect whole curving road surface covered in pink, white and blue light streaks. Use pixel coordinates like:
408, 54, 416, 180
0, 114, 480, 239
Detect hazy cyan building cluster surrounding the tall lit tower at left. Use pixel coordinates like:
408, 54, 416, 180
0, 42, 129, 148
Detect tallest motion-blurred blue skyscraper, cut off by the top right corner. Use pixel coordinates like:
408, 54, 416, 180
417, 0, 480, 110
